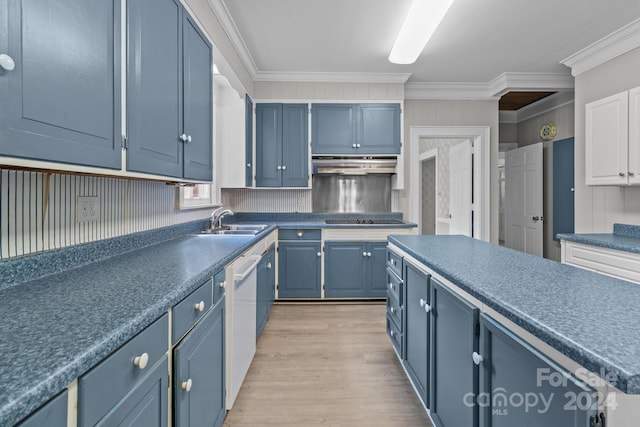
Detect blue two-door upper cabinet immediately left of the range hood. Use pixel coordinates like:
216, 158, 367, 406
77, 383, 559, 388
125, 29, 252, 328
256, 104, 309, 187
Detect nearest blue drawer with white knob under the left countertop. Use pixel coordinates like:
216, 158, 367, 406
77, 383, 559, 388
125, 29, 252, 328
78, 314, 169, 427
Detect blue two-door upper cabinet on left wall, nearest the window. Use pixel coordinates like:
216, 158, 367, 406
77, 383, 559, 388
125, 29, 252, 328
127, 0, 213, 181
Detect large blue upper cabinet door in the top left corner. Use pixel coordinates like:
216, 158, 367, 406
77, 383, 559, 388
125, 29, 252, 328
0, 0, 121, 169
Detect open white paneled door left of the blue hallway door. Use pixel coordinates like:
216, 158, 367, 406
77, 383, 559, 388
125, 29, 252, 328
505, 142, 543, 257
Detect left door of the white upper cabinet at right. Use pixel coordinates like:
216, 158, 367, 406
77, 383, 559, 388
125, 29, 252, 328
585, 92, 629, 185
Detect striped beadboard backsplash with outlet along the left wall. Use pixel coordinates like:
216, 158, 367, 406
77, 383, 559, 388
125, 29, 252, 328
0, 170, 211, 259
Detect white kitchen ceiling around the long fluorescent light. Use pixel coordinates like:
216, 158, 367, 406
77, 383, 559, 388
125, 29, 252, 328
218, 0, 640, 83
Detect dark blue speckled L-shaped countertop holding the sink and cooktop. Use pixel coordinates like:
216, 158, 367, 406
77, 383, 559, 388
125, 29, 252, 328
0, 213, 416, 426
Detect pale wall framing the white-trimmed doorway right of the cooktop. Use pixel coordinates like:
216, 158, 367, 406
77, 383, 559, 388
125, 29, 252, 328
398, 100, 498, 243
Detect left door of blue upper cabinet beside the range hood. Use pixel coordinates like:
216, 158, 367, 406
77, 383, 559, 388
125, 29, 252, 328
256, 104, 282, 187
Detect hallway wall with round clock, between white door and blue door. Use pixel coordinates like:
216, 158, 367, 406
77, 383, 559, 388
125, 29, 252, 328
516, 102, 575, 261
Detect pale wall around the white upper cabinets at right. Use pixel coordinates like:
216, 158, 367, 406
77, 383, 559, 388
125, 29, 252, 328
575, 48, 640, 233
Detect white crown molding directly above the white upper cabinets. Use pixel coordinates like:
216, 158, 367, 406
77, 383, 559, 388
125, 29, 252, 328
560, 19, 640, 77
